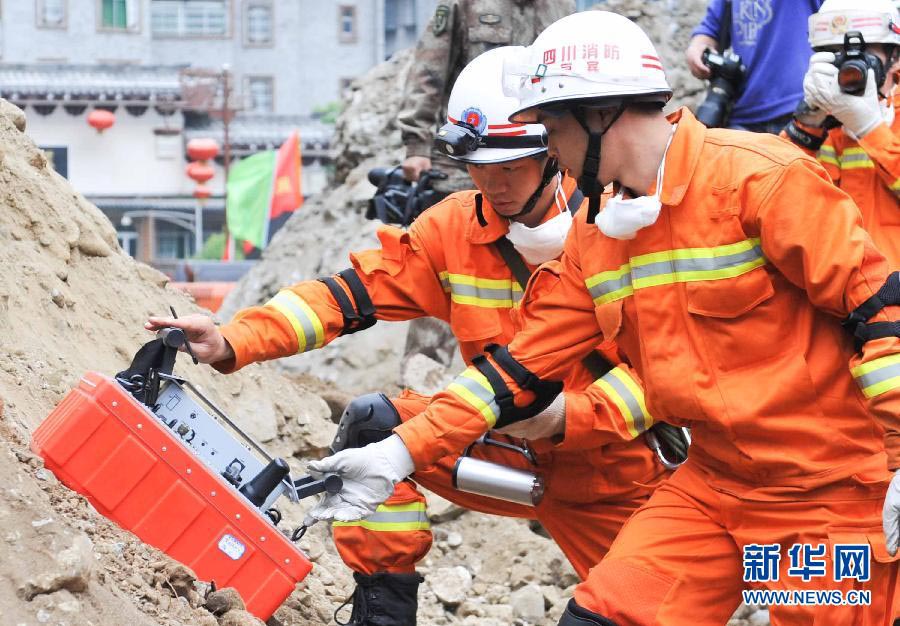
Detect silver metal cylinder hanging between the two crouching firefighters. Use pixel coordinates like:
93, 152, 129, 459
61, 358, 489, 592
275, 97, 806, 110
453, 456, 544, 506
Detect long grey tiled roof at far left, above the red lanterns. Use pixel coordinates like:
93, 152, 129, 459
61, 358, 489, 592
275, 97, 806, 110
0, 64, 183, 103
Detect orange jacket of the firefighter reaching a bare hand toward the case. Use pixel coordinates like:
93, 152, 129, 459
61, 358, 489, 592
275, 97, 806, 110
216, 178, 660, 494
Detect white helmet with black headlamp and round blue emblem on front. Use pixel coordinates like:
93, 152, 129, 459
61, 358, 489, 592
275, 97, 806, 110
436, 46, 547, 163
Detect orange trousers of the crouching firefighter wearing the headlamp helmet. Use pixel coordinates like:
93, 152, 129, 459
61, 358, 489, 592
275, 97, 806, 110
332, 391, 650, 580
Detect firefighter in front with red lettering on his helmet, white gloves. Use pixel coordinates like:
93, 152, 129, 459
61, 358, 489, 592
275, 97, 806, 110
310, 11, 900, 626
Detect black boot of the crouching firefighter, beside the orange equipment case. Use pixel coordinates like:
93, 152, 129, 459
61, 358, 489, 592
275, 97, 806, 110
334, 572, 425, 626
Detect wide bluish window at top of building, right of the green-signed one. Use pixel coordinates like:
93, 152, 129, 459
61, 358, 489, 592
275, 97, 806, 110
150, 0, 229, 37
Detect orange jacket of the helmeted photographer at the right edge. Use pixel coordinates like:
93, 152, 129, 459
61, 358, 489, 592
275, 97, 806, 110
782, 95, 900, 267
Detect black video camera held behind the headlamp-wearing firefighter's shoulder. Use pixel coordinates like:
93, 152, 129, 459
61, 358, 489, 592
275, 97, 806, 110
366, 165, 447, 226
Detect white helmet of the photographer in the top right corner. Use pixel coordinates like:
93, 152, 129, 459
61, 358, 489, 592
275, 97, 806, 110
809, 0, 900, 49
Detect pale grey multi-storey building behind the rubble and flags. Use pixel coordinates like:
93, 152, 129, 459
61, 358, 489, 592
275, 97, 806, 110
0, 0, 436, 260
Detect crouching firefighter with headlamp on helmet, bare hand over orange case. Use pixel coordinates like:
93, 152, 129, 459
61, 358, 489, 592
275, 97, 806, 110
147, 48, 666, 626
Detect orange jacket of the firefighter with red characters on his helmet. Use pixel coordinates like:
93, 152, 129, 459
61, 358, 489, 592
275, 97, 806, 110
397, 110, 900, 486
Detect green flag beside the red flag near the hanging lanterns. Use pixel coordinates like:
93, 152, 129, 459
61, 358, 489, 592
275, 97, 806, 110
226, 150, 275, 248
